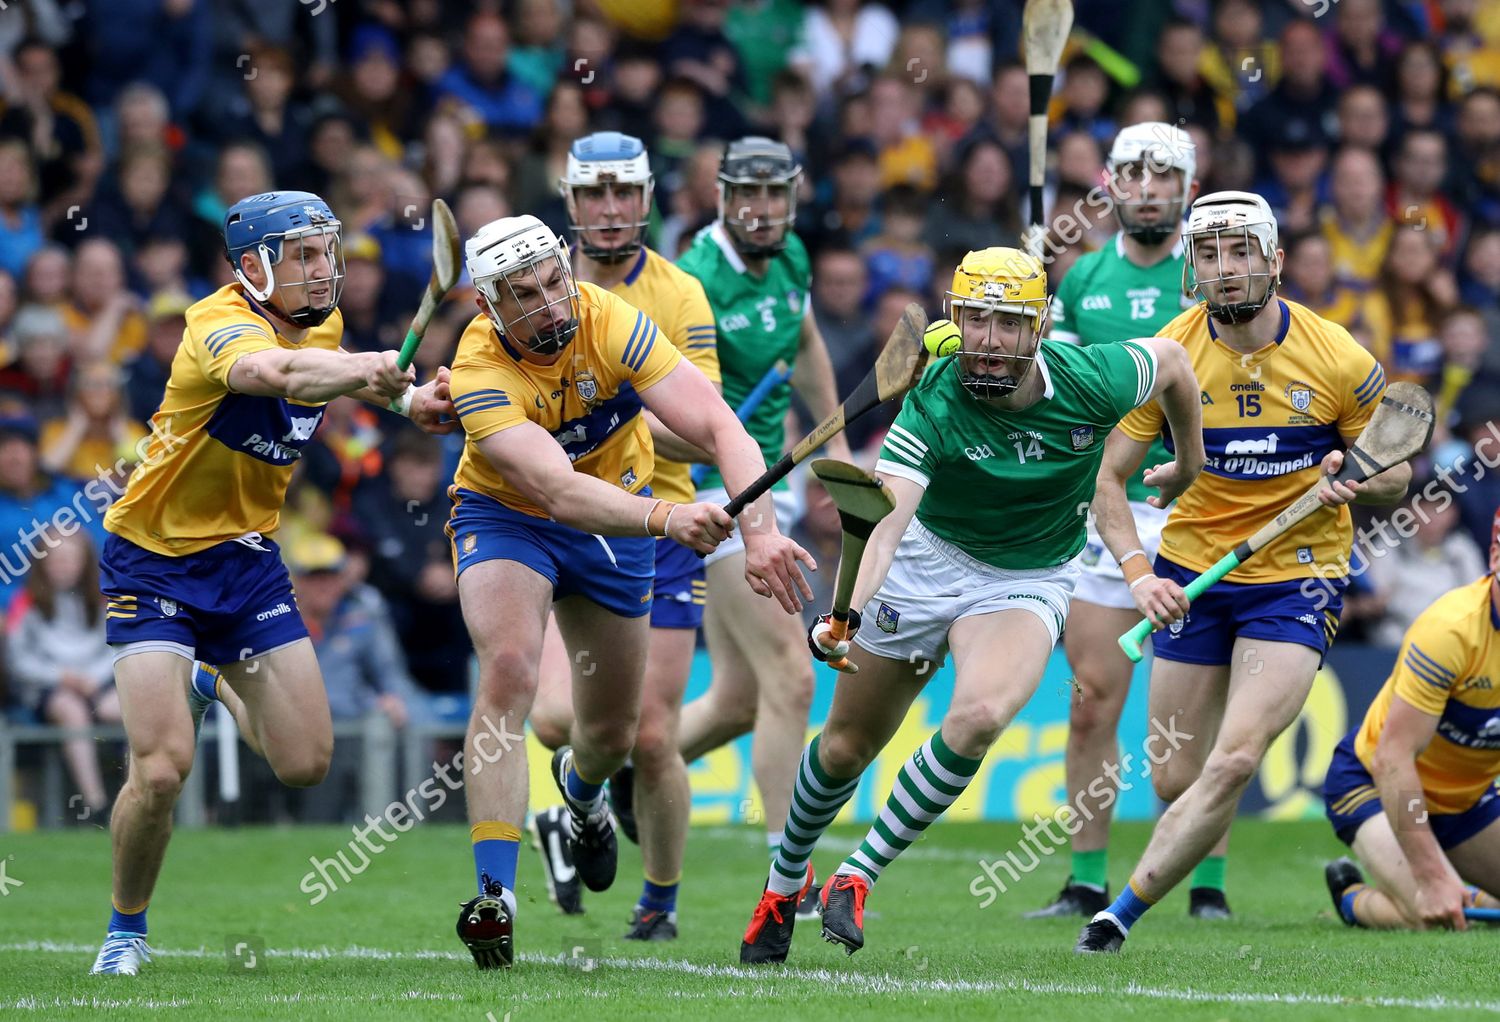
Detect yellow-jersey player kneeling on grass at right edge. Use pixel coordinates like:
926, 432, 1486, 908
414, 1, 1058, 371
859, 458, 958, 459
1323, 512, 1500, 929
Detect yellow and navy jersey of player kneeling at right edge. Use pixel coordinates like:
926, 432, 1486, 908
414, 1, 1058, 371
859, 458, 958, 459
1355, 575, 1500, 813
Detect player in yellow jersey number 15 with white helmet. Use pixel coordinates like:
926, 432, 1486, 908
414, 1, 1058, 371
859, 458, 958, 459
1077, 192, 1412, 951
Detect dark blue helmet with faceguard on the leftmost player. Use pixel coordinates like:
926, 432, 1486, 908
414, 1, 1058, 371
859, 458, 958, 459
224, 192, 344, 327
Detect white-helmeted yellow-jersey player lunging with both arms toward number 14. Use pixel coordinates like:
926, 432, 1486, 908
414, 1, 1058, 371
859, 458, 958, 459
449, 216, 813, 968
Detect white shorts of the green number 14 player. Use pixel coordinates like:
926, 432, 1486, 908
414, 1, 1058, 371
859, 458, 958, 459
855, 518, 1079, 668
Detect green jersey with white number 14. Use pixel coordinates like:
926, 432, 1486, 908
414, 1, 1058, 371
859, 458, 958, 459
876, 341, 1157, 570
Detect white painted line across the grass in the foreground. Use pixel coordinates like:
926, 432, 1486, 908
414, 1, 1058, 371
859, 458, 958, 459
11, 941, 1500, 1014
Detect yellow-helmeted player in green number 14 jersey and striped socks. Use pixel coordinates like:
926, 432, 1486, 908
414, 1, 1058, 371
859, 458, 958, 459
740, 248, 1203, 962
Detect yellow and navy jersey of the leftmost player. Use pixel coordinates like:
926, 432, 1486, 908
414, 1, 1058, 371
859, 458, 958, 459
104, 284, 344, 557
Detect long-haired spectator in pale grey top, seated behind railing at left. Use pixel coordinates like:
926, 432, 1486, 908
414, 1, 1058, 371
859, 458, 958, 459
6, 531, 120, 813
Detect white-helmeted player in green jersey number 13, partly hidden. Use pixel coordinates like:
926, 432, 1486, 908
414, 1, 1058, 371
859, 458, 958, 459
1026, 122, 1229, 918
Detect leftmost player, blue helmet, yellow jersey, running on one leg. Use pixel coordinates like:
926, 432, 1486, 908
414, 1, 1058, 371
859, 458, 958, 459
93, 192, 458, 975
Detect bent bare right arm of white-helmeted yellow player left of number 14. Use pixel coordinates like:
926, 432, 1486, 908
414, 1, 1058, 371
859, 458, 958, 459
479, 422, 732, 554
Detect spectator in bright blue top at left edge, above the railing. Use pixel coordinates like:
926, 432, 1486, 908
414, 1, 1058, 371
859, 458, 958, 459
0, 405, 110, 608
